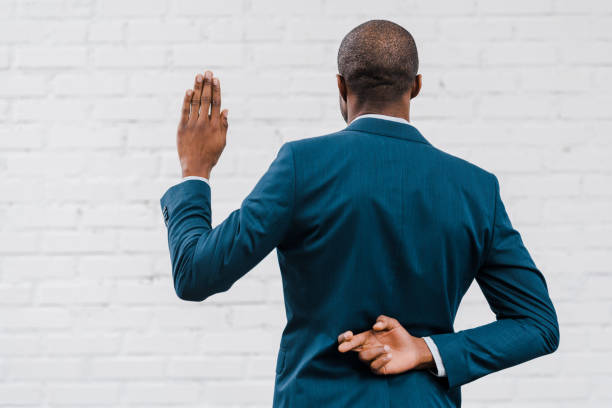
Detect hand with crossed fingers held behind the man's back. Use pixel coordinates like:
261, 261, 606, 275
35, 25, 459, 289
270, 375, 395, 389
338, 315, 435, 375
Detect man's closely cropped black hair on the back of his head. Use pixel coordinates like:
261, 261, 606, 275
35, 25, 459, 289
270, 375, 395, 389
338, 20, 419, 102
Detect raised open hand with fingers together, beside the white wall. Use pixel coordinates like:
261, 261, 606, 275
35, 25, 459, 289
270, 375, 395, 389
176, 71, 228, 178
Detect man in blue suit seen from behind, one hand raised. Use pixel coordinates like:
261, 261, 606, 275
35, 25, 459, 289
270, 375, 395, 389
161, 20, 559, 408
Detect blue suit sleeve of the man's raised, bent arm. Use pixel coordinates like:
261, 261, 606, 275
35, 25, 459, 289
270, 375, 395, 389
160, 143, 295, 301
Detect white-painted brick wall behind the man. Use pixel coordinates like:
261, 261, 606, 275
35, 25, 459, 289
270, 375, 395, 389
0, 0, 612, 408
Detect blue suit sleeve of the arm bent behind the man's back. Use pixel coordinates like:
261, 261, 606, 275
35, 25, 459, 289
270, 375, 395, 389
430, 176, 560, 388
